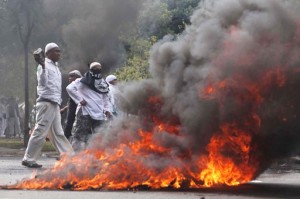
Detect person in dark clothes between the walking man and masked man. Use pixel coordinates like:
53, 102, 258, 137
61, 70, 82, 139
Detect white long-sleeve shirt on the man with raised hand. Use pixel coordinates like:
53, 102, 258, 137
37, 58, 62, 104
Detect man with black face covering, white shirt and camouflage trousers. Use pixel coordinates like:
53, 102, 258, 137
67, 62, 111, 151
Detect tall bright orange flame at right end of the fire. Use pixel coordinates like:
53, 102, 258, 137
200, 121, 256, 187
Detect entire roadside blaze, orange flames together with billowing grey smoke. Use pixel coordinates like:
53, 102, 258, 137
5, 0, 300, 190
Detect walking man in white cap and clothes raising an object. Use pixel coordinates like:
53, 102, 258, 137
22, 43, 73, 168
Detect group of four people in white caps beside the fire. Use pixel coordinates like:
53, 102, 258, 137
22, 43, 118, 168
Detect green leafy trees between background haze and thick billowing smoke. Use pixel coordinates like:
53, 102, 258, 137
115, 0, 201, 81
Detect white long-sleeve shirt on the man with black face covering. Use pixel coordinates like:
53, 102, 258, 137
66, 78, 111, 120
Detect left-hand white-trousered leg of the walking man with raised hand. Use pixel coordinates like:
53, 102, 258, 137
23, 102, 54, 166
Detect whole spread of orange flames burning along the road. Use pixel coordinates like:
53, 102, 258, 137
11, 117, 255, 190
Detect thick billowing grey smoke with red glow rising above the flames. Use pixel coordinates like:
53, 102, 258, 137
119, 0, 300, 171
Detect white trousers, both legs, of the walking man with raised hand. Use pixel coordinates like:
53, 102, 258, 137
23, 102, 73, 162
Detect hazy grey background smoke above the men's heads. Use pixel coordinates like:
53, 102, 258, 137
45, 0, 143, 72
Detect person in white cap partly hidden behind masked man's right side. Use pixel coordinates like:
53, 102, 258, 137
105, 75, 120, 116
